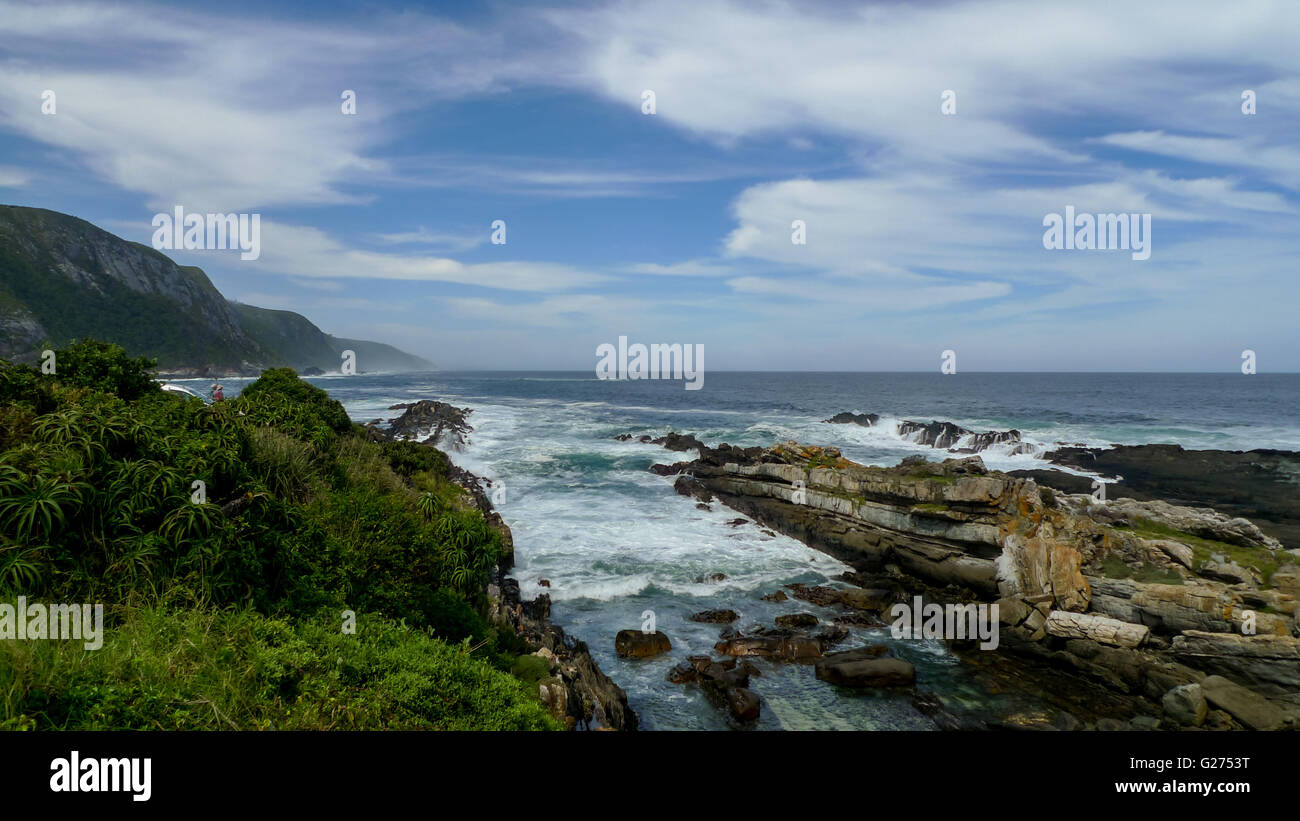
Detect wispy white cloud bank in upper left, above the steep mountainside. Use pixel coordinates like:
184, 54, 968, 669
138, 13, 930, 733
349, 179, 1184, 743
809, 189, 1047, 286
0, 3, 553, 212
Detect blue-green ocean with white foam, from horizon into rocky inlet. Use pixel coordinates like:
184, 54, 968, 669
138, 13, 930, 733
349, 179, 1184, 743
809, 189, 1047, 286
183, 372, 1300, 730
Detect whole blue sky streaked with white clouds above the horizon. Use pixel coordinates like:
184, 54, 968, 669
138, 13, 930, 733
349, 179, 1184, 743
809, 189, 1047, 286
0, 0, 1300, 373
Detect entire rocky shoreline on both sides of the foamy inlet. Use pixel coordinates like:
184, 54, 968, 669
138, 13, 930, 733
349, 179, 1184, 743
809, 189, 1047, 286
369, 400, 1300, 730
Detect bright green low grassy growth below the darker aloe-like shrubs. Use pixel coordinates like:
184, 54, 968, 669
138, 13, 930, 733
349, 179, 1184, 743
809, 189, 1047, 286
0, 607, 559, 730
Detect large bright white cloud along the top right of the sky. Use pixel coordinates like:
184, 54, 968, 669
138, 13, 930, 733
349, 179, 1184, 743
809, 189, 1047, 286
547, 0, 1300, 165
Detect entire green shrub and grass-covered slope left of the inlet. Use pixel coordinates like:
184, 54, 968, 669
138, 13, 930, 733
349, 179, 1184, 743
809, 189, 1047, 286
0, 342, 558, 730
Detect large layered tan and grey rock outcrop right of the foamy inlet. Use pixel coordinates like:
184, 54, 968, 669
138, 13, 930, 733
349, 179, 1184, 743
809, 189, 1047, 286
642, 431, 1300, 730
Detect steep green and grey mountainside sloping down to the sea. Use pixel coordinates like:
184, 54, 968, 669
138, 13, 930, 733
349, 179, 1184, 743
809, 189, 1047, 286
0, 205, 433, 374
